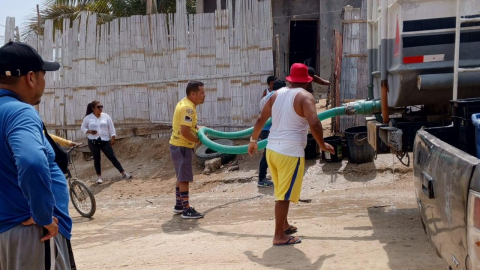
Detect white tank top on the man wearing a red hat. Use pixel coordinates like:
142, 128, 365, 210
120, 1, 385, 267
267, 87, 308, 157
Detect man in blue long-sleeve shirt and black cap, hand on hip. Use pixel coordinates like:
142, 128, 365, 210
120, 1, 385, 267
0, 42, 74, 270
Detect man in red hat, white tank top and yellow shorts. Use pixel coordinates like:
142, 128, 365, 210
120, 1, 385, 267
248, 64, 334, 246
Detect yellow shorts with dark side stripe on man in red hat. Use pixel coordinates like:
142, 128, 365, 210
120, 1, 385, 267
267, 149, 305, 203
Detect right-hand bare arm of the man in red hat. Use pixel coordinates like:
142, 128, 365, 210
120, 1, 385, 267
301, 93, 335, 153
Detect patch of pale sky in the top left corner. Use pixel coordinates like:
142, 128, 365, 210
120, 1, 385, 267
0, 0, 44, 43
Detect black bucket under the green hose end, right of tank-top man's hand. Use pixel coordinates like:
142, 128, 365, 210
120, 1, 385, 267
345, 126, 375, 164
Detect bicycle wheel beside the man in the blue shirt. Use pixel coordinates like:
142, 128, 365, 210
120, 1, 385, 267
70, 180, 97, 217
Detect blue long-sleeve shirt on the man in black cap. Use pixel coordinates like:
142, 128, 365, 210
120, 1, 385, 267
0, 89, 72, 239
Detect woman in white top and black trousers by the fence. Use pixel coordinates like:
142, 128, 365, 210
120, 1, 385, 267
82, 100, 132, 184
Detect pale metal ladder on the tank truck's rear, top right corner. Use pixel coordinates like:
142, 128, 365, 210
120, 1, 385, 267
453, 0, 480, 100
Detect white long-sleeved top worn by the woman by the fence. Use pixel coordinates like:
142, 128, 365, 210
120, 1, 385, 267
82, 113, 116, 141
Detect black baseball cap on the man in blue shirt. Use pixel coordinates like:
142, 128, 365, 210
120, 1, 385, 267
0, 41, 60, 77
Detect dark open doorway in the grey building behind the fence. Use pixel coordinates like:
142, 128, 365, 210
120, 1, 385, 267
287, 20, 318, 72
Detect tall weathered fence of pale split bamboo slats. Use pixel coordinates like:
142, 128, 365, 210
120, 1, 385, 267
5, 0, 273, 140
